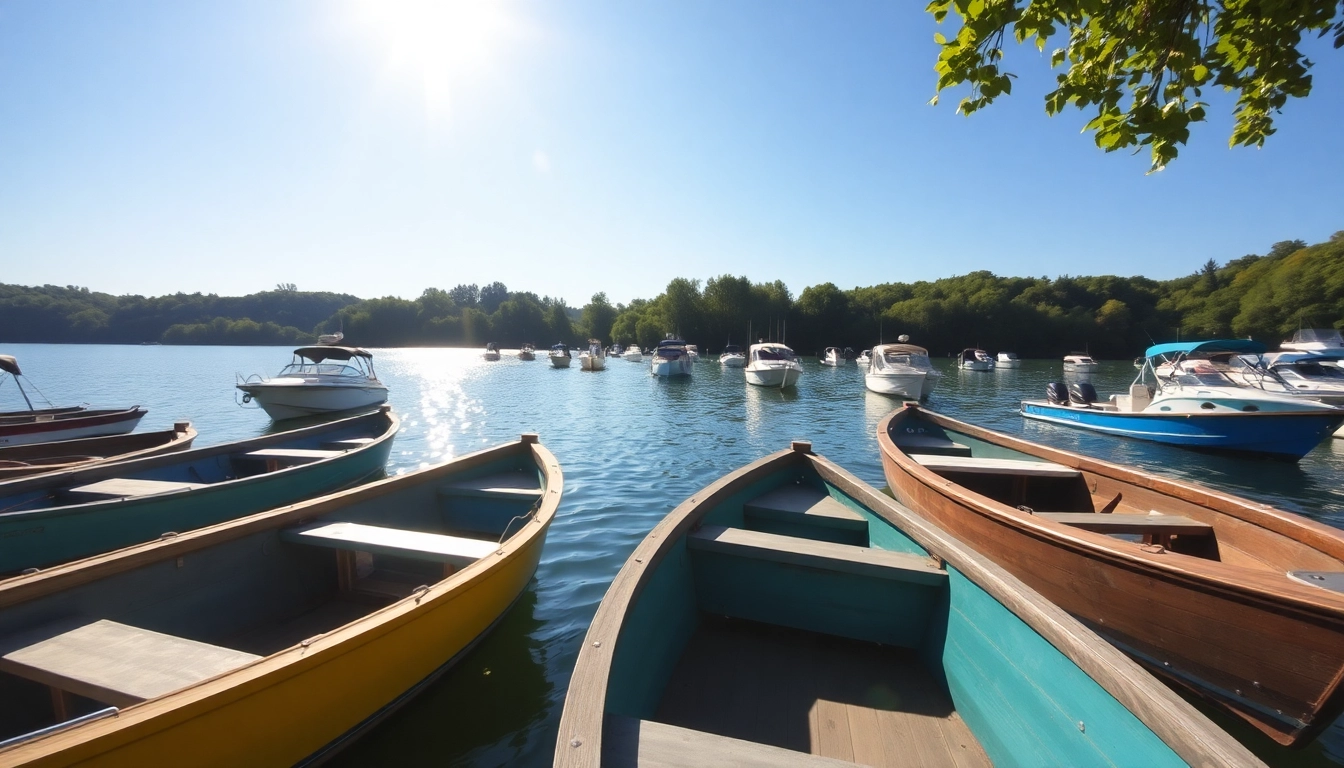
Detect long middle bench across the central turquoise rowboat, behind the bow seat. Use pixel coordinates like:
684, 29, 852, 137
685, 526, 948, 585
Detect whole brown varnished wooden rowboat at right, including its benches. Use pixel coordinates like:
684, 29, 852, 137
878, 404, 1344, 745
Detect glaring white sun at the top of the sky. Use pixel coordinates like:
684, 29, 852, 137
353, 0, 511, 117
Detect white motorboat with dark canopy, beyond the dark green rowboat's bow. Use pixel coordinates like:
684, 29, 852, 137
238, 344, 387, 421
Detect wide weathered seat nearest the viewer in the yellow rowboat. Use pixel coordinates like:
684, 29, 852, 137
0, 619, 261, 720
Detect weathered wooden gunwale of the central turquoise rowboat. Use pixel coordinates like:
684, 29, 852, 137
554, 444, 1262, 768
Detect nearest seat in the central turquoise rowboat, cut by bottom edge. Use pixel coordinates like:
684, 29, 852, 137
602, 714, 853, 768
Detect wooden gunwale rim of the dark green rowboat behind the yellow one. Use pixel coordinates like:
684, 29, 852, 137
0, 404, 401, 521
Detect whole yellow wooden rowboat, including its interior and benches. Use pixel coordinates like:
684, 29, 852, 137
0, 436, 563, 767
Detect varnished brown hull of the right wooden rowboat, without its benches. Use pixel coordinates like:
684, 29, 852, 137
878, 406, 1344, 745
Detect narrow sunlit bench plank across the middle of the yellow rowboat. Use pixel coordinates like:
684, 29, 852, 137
280, 523, 499, 568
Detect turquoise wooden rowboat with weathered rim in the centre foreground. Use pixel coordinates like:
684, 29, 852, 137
555, 443, 1261, 768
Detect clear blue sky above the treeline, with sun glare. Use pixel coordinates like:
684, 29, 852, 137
0, 0, 1344, 305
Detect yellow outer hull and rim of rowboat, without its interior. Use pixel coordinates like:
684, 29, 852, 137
0, 437, 563, 767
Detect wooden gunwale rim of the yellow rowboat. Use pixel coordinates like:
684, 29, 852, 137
0, 436, 563, 764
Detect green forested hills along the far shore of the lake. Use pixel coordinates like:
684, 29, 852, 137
0, 231, 1344, 359
